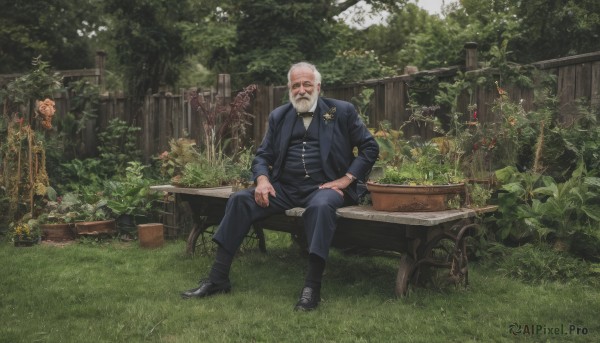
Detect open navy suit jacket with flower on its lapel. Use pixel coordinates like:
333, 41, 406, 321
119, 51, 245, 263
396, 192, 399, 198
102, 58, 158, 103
252, 98, 379, 202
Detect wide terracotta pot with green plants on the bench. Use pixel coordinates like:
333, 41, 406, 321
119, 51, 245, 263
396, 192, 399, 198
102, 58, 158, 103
367, 137, 465, 212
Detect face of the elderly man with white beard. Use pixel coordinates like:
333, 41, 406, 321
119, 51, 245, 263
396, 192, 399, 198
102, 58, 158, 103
289, 67, 321, 112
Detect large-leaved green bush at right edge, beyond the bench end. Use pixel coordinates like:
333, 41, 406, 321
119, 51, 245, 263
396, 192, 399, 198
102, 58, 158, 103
494, 163, 600, 255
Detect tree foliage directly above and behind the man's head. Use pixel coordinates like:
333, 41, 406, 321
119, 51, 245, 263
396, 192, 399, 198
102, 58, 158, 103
188, 0, 404, 88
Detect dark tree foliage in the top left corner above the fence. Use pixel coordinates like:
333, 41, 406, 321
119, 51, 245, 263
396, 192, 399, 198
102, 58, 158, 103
0, 0, 100, 73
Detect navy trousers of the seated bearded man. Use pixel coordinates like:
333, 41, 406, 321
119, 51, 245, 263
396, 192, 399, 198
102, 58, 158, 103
213, 178, 351, 260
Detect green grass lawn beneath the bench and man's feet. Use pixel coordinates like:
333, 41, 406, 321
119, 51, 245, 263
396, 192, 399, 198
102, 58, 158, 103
0, 236, 600, 342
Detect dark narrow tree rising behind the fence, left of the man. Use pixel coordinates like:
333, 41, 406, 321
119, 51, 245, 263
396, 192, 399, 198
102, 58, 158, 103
105, 0, 196, 97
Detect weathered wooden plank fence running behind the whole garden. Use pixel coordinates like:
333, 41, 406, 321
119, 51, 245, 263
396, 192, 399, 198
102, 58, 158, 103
3, 48, 600, 161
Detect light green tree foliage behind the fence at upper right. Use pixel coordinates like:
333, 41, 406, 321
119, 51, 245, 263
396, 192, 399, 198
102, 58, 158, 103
363, 0, 600, 69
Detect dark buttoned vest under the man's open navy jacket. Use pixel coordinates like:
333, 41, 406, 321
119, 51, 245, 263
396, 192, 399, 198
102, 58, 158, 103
280, 117, 325, 183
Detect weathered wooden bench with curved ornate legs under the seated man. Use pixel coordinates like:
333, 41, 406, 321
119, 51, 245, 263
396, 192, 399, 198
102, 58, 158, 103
151, 185, 496, 296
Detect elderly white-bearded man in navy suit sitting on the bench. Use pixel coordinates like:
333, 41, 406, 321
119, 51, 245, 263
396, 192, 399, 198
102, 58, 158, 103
182, 62, 379, 311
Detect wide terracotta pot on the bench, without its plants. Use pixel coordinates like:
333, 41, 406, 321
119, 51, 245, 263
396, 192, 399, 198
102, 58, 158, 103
367, 182, 465, 212
